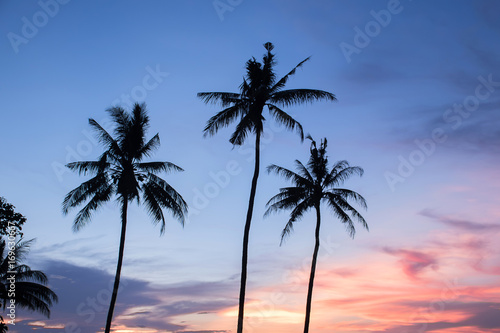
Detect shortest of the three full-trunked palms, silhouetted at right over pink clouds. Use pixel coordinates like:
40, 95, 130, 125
265, 136, 368, 333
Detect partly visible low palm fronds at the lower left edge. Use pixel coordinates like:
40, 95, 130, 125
0, 239, 58, 318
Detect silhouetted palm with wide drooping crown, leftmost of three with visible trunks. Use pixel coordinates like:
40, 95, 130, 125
63, 103, 187, 333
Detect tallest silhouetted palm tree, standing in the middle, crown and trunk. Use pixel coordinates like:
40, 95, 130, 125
198, 43, 336, 333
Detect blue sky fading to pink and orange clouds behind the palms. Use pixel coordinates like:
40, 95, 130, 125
0, 0, 500, 333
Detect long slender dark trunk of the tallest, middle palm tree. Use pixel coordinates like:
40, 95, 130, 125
236, 131, 260, 333
